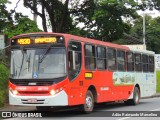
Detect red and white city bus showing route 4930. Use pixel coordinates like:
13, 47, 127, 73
9, 32, 156, 112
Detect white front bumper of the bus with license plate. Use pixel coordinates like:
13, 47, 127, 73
9, 90, 68, 106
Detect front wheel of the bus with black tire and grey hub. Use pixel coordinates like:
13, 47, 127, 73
80, 90, 94, 113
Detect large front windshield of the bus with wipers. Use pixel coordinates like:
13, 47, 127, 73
10, 47, 66, 79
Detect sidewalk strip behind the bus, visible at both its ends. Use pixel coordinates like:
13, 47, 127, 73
0, 93, 160, 112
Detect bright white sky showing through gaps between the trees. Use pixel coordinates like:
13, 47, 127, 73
7, 0, 160, 31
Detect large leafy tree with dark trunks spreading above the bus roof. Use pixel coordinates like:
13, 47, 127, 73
24, 0, 140, 41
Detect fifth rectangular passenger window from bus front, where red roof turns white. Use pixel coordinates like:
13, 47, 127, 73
126, 52, 134, 71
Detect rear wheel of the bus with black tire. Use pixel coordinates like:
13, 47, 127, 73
124, 87, 140, 105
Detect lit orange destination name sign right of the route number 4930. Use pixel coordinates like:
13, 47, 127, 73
35, 37, 57, 44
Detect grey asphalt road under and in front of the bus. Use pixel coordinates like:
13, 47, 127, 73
0, 97, 160, 120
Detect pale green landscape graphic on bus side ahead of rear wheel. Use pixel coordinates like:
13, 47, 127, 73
113, 72, 135, 86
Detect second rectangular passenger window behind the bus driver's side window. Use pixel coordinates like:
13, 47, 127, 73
97, 47, 106, 70
